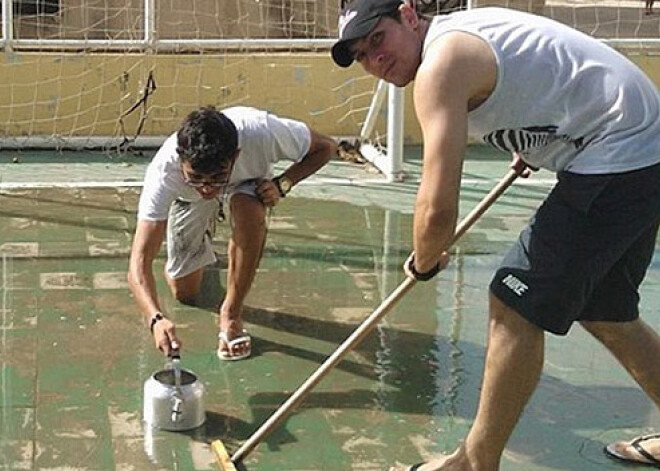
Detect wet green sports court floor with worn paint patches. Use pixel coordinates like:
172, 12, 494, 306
0, 150, 660, 471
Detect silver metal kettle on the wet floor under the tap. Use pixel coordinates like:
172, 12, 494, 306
143, 352, 206, 431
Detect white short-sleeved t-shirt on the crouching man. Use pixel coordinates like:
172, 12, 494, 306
138, 107, 312, 221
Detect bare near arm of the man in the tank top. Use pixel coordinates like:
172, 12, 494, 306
413, 33, 497, 273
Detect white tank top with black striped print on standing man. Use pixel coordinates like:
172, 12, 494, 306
424, 8, 660, 174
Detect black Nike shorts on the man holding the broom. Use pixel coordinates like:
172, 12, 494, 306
490, 164, 660, 335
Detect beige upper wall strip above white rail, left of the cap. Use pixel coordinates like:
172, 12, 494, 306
14, 0, 338, 39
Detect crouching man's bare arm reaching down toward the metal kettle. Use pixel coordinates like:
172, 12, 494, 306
128, 220, 181, 354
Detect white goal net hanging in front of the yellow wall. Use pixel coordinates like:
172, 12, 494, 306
0, 0, 660, 155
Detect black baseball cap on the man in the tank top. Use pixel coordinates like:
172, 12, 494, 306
332, 0, 403, 67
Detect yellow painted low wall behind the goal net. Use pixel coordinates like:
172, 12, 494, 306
0, 47, 660, 144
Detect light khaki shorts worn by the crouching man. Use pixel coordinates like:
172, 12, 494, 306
165, 180, 258, 279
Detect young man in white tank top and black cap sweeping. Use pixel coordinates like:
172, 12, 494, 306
332, 0, 660, 471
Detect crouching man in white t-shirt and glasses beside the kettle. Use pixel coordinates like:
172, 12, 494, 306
128, 107, 337, 360
